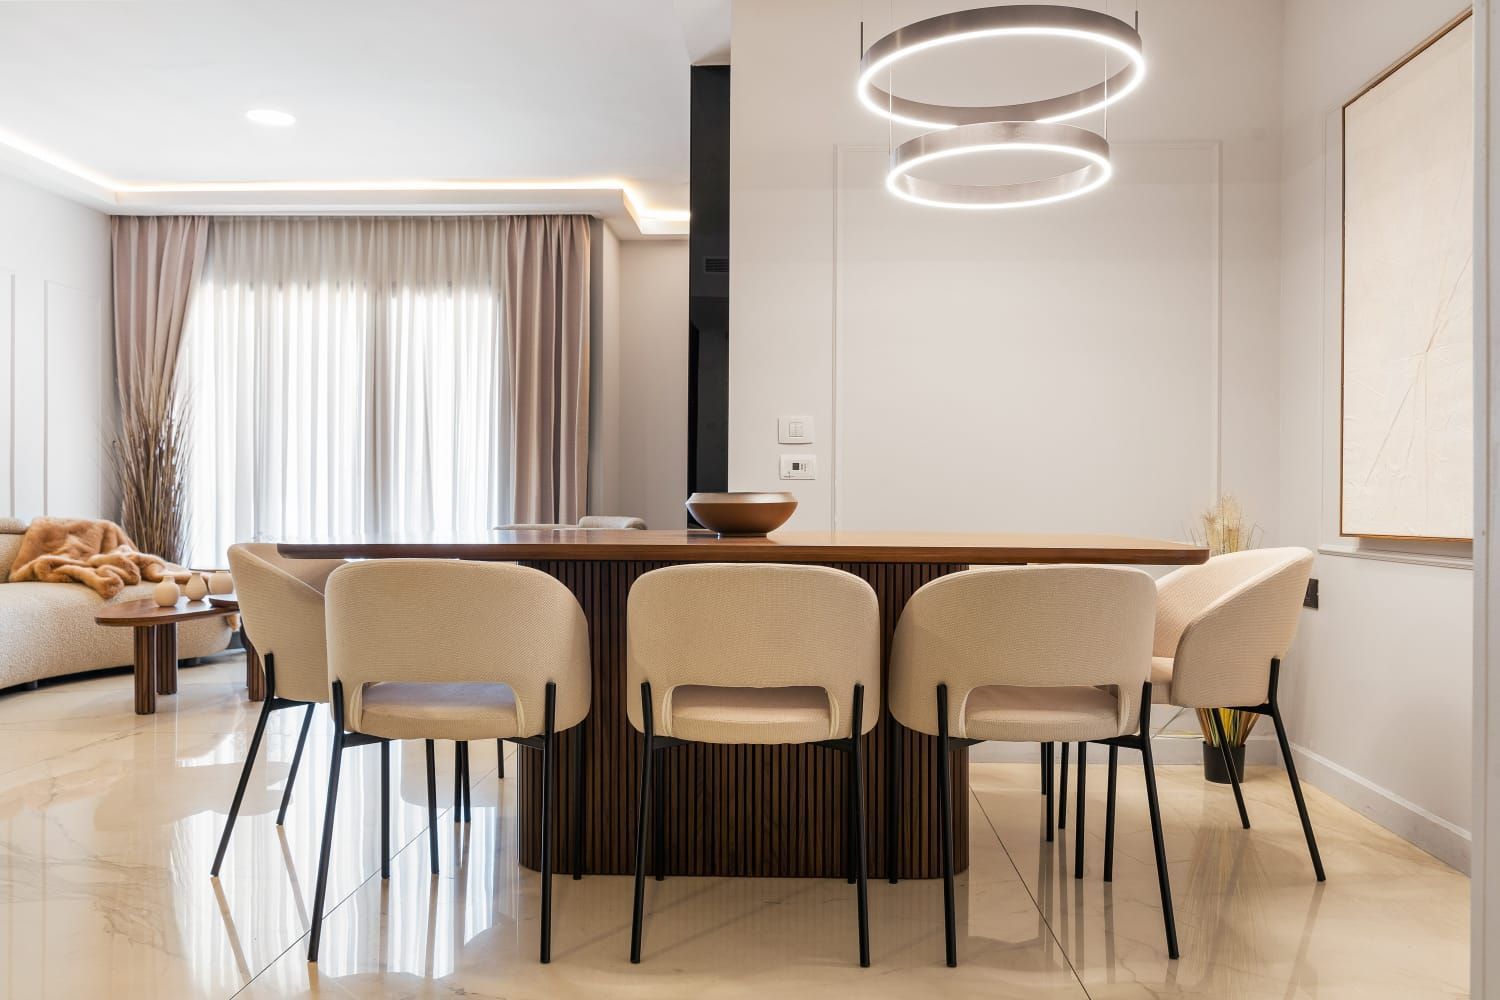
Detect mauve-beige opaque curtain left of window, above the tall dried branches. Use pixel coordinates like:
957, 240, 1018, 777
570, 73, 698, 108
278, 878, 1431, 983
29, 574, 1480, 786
111, 216, 209, 412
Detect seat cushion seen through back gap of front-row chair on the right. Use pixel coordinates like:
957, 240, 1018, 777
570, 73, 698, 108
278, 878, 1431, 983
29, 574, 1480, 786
963, 685, 1121, 742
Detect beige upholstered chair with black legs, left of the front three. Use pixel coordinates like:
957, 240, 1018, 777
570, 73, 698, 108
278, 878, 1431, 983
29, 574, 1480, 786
308, 559, 590, 963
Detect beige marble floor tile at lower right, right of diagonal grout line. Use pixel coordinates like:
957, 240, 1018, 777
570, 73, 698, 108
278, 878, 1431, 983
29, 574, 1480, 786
972, 754, 1469, 999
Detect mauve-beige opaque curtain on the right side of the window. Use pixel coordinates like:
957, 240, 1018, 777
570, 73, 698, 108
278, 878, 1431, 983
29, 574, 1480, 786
504, 216, 590, 525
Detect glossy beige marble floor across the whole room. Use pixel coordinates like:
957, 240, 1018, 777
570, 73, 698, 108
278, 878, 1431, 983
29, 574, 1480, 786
0, 658, 1469, 1000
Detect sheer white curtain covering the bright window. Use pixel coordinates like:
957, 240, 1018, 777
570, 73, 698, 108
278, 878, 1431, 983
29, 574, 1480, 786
182, 217, 513, 565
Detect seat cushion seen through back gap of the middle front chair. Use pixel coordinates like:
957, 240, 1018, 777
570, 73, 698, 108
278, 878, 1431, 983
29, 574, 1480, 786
668, 684, 834, 744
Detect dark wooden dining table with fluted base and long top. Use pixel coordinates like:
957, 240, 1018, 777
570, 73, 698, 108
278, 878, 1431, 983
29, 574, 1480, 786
278, 528, 1209, 879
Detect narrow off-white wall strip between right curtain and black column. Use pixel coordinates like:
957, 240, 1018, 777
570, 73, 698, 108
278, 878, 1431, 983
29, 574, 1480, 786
617, 240, 687, 528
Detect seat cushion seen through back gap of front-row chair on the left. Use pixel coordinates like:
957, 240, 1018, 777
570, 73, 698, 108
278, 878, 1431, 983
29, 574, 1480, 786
360, 682, 521, 739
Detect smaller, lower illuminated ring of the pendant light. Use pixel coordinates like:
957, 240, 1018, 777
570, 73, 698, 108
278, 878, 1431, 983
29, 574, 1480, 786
885, 121, 1115, 211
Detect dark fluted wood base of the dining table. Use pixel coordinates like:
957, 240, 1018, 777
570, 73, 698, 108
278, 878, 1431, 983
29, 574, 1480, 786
519, 561, 969, 879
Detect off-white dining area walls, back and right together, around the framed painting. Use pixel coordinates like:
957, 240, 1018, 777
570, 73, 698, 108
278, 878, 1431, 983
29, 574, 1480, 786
729, 0, 1472, 864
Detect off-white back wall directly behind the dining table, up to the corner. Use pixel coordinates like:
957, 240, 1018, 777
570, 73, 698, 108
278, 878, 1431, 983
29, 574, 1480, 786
729, 0, 1281, 535
